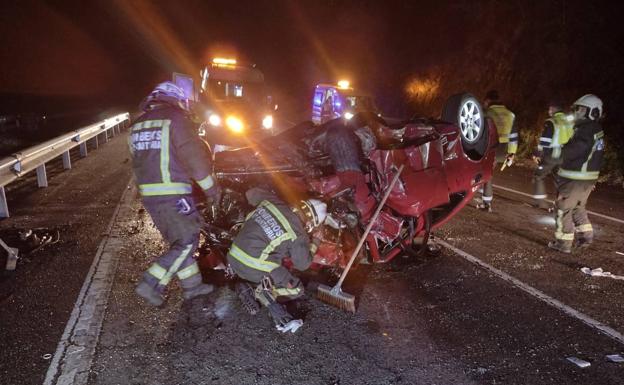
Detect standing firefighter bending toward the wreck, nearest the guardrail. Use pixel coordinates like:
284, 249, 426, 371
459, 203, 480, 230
129, 82, 219, 306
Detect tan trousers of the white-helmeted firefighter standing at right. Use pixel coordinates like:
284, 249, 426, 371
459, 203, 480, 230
555, 178, 596, 244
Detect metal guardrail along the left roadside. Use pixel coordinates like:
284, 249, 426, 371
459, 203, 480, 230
0, 112, 130, 218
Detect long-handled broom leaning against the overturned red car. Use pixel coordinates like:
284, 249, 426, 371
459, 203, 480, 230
316, 165, 403, 313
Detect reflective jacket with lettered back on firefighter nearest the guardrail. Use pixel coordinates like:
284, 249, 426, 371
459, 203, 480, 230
129, 105, 214, 196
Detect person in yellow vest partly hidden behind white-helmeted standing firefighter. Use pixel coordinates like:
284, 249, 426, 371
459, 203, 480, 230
533, 102, 574, 209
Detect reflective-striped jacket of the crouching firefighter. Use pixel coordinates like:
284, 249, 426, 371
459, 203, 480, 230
228, 188, 312, 280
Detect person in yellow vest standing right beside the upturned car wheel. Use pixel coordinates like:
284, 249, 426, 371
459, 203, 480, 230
477, 90, 518, 212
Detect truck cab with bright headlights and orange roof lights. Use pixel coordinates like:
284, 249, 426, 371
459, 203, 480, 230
199, 58, 273, 144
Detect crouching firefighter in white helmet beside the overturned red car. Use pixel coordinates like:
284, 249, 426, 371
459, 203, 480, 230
227, 188, 327, 333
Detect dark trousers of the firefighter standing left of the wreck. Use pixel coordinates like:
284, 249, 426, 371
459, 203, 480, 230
143, 196, 202, 293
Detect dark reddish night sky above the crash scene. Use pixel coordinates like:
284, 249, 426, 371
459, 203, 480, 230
0, 0, 623, 124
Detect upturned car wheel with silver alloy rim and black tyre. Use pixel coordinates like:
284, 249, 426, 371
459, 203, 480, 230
442, 93, 489, 160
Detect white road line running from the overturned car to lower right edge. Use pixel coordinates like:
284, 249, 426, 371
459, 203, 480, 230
435, 238, 624, 344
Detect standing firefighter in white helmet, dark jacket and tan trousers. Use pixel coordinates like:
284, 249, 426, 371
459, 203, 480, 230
548, 94, 605, 253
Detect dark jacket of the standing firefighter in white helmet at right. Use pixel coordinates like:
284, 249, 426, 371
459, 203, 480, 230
558, 119, 605, 180
